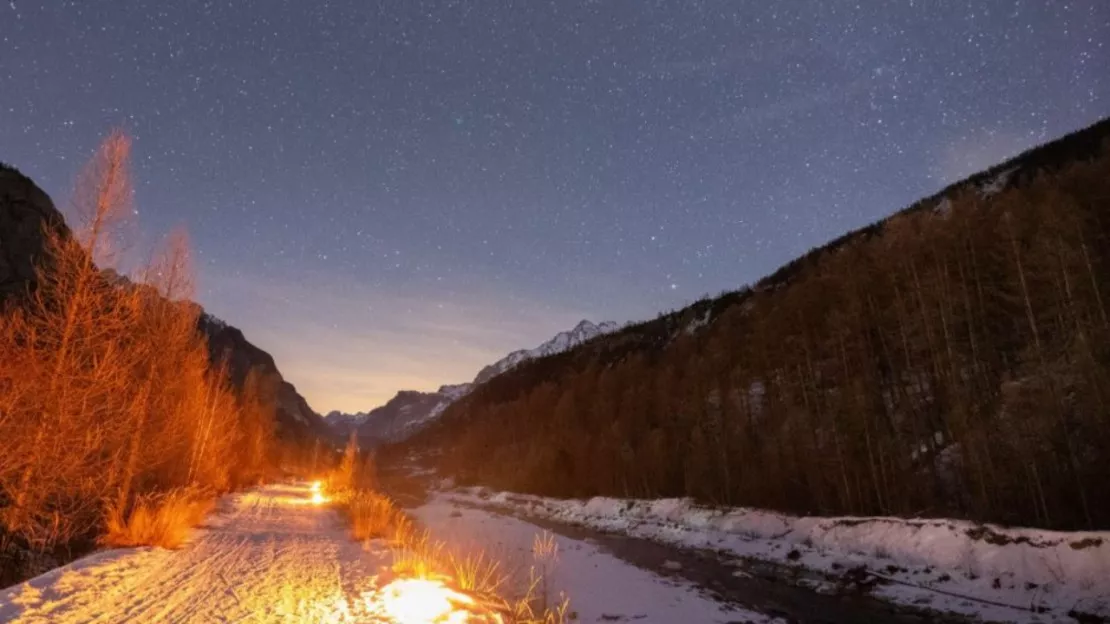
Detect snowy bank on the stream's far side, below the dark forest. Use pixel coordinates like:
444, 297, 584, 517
450, 489, 1110, 622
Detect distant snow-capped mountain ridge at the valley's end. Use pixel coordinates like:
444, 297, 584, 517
325, 321, 620, 445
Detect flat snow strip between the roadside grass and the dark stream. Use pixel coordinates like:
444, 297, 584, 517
410, 494, 775, 624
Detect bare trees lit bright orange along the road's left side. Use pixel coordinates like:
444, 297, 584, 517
0, 134, 293, 581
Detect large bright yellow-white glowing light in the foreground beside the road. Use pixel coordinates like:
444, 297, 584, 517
366, 578, 501, 624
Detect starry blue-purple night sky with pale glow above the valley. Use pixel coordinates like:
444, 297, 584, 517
0, 0, 1110, 411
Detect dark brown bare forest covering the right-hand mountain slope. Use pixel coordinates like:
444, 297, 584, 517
412, 124, 1110, 529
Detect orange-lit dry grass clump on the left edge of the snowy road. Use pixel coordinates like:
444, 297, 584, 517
100, 489, 214, 548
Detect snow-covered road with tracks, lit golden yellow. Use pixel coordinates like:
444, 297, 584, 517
0, 485, 389, 623
